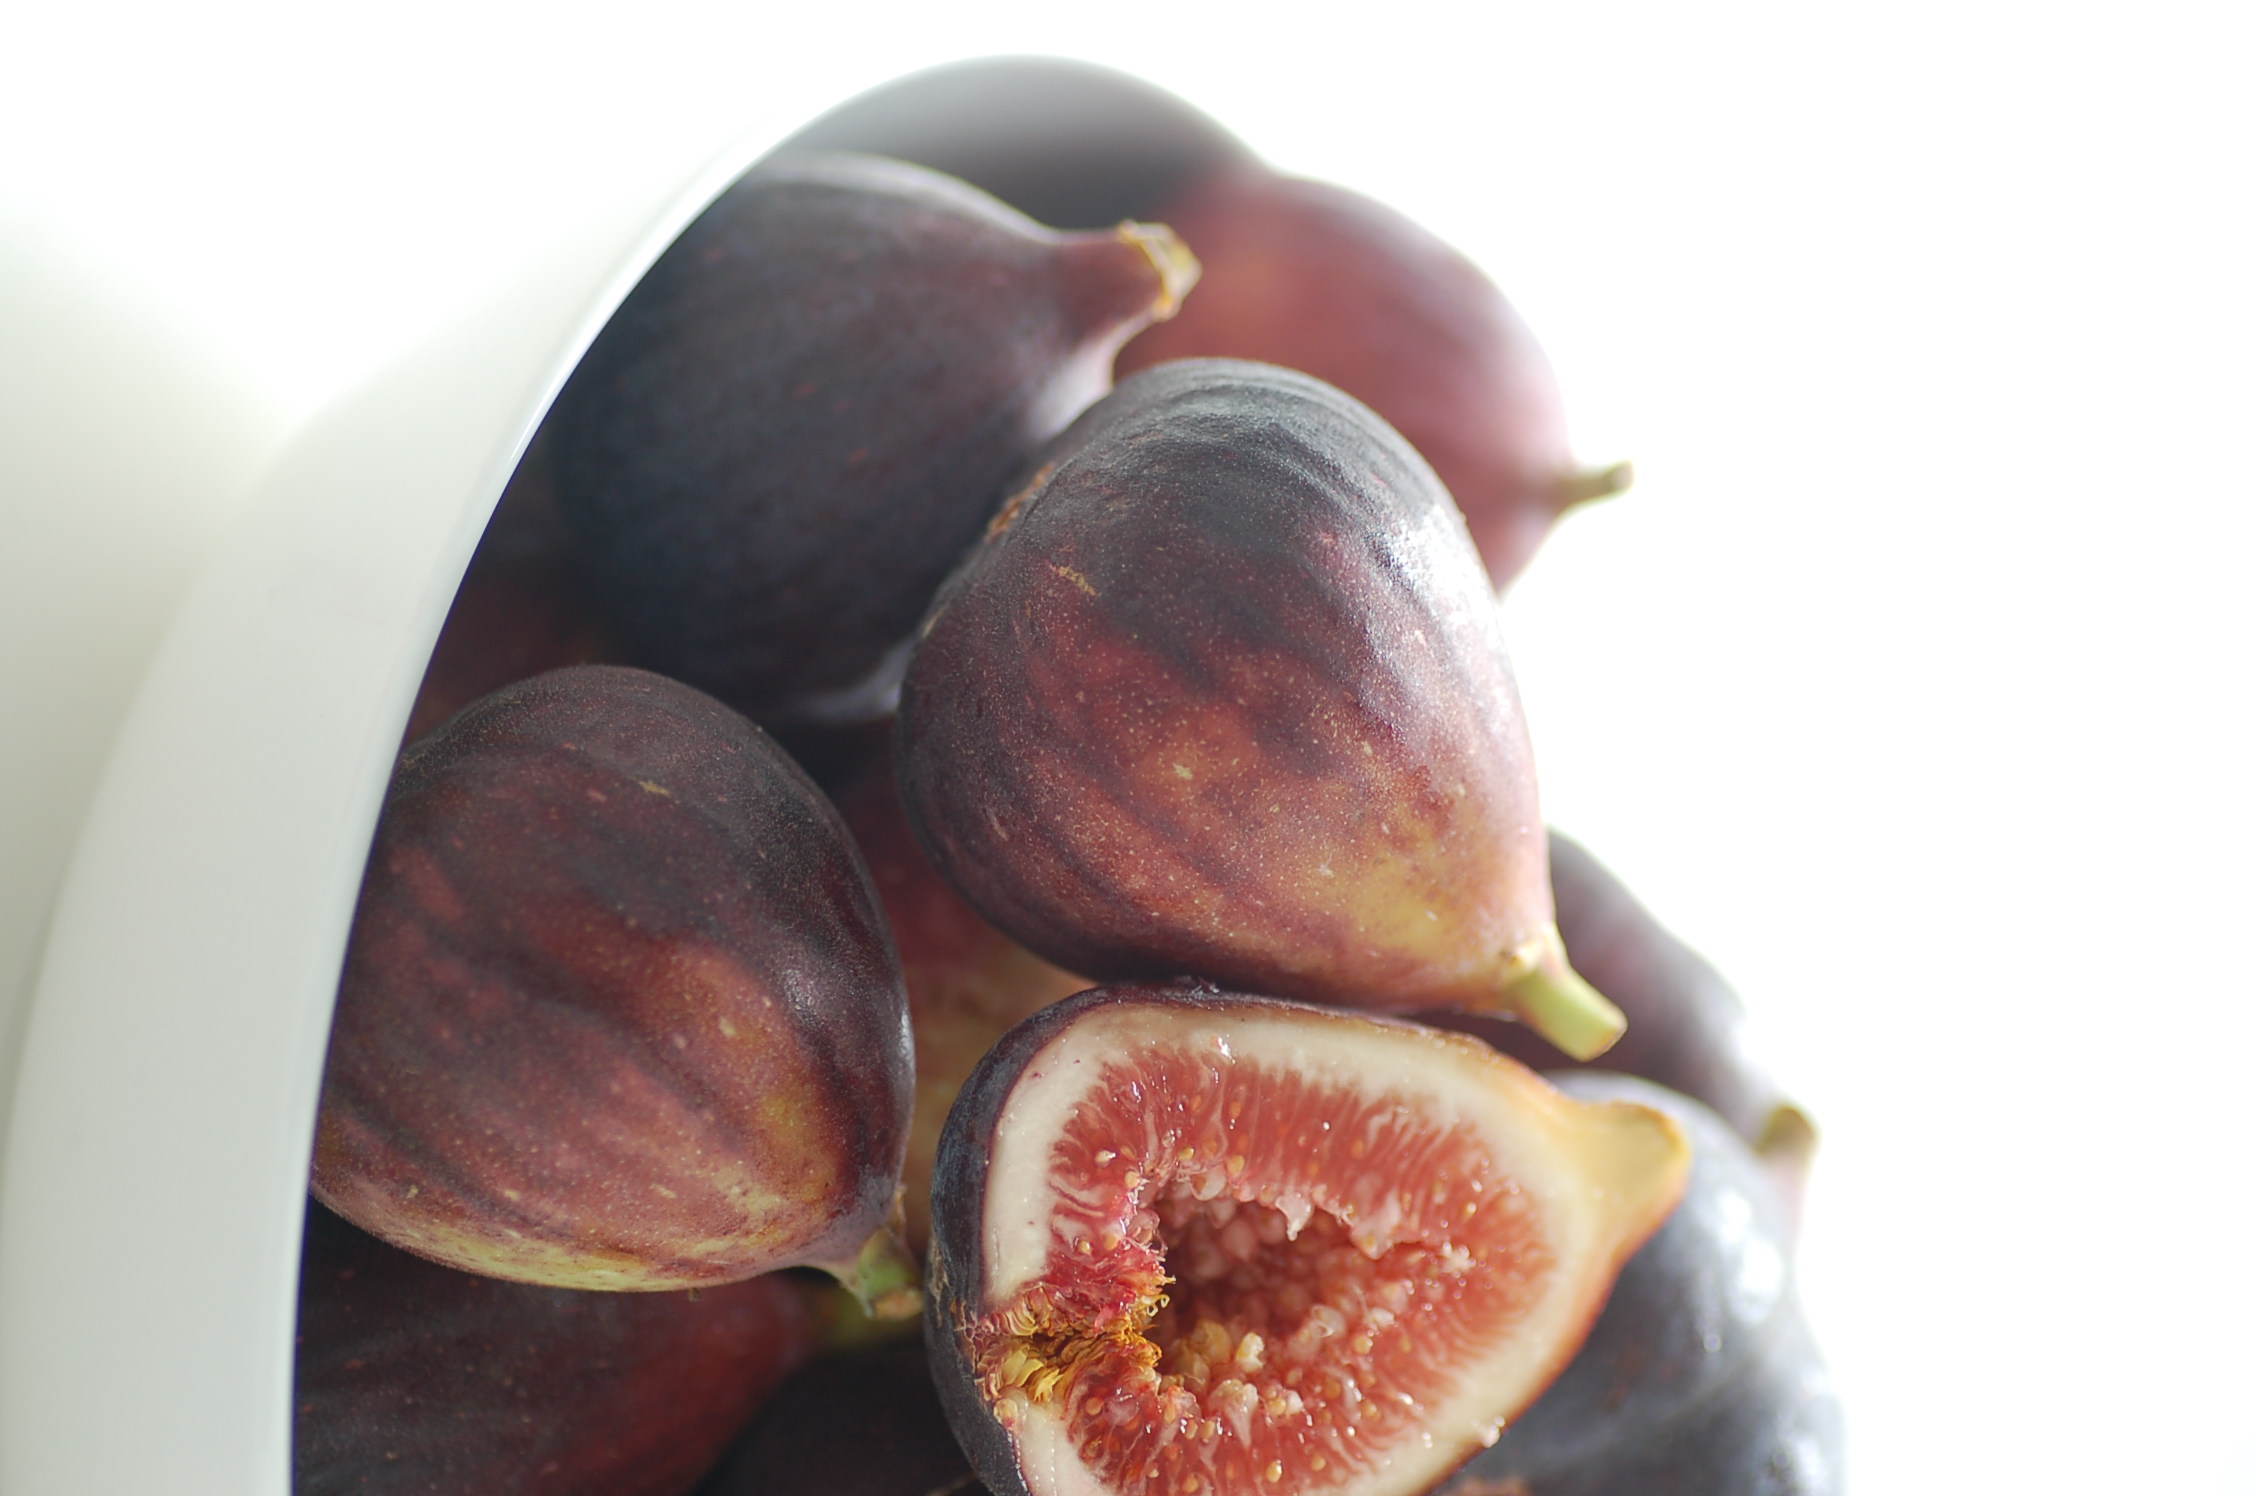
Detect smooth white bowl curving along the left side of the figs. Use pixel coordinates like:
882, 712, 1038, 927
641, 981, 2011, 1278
0, 113, 812, 1496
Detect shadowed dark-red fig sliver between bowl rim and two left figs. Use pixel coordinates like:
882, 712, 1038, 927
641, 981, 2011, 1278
406, 447, 629, 742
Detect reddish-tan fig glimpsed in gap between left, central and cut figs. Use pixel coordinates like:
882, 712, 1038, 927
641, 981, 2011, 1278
837, 756, 1090, 1255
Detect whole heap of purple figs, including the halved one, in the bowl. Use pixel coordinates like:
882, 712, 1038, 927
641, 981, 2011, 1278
296, 59, 1841, 1496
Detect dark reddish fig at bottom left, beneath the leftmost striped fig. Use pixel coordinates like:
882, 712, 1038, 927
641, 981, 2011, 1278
293, 1205, 817, 1496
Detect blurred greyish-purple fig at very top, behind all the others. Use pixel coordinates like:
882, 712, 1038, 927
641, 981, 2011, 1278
781, 56, 1254, 228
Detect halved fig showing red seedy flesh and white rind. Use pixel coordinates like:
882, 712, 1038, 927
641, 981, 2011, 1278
927, 986, 1690, 1496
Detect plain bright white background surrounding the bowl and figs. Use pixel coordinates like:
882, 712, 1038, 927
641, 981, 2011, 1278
0, 2, 2256, 1496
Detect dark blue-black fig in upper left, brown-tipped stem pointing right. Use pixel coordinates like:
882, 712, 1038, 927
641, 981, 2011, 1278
544, 153, 1198, 722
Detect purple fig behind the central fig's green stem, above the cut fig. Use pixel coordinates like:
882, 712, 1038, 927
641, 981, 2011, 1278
1419, 830, 1816, 1198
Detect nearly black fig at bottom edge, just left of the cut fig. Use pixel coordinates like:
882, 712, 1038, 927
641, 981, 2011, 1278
697, 1340, 984, 1496
